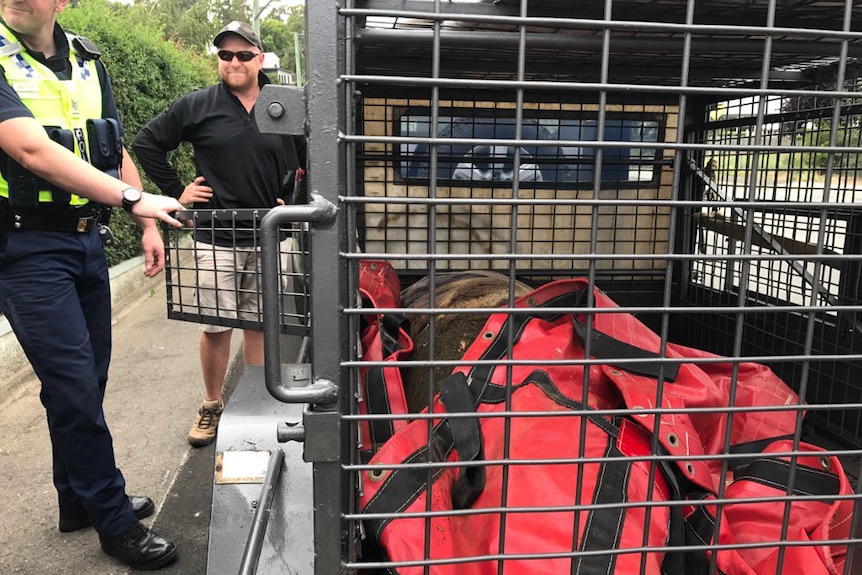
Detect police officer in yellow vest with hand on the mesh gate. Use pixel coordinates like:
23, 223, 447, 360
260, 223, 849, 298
0, 0, 182, 569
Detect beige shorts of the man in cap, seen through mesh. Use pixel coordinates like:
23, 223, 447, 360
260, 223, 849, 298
194, 237, 303, 333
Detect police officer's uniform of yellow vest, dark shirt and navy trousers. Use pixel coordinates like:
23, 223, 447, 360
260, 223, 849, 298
0, 23, 137, 537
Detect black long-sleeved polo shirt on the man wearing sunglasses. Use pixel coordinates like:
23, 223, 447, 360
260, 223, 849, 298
132, 74, 288, 245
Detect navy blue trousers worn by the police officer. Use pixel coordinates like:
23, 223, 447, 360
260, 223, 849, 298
0, 230, 137, 537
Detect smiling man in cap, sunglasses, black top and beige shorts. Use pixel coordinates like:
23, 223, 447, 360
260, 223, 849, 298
132, 21, 300, 447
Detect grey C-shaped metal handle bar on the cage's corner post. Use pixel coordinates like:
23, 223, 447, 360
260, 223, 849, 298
260, 192, 338, 405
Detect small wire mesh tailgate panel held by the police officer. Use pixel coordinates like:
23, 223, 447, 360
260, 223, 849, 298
164, 209, 310, 335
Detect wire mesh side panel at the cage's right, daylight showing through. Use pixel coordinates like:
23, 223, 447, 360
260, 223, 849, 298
686, 92, 862, 452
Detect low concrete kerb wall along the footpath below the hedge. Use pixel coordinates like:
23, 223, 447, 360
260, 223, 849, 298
0, 256, 159, 405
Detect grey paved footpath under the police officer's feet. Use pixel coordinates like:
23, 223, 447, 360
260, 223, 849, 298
0, 267, 242, 575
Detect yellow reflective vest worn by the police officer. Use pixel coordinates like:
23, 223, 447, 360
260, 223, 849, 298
0, 23, 102, 205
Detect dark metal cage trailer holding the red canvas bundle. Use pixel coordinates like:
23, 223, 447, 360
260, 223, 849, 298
164, 0, 862, 575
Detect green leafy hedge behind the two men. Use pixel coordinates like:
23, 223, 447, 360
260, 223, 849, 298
59, 0, 218, 265
